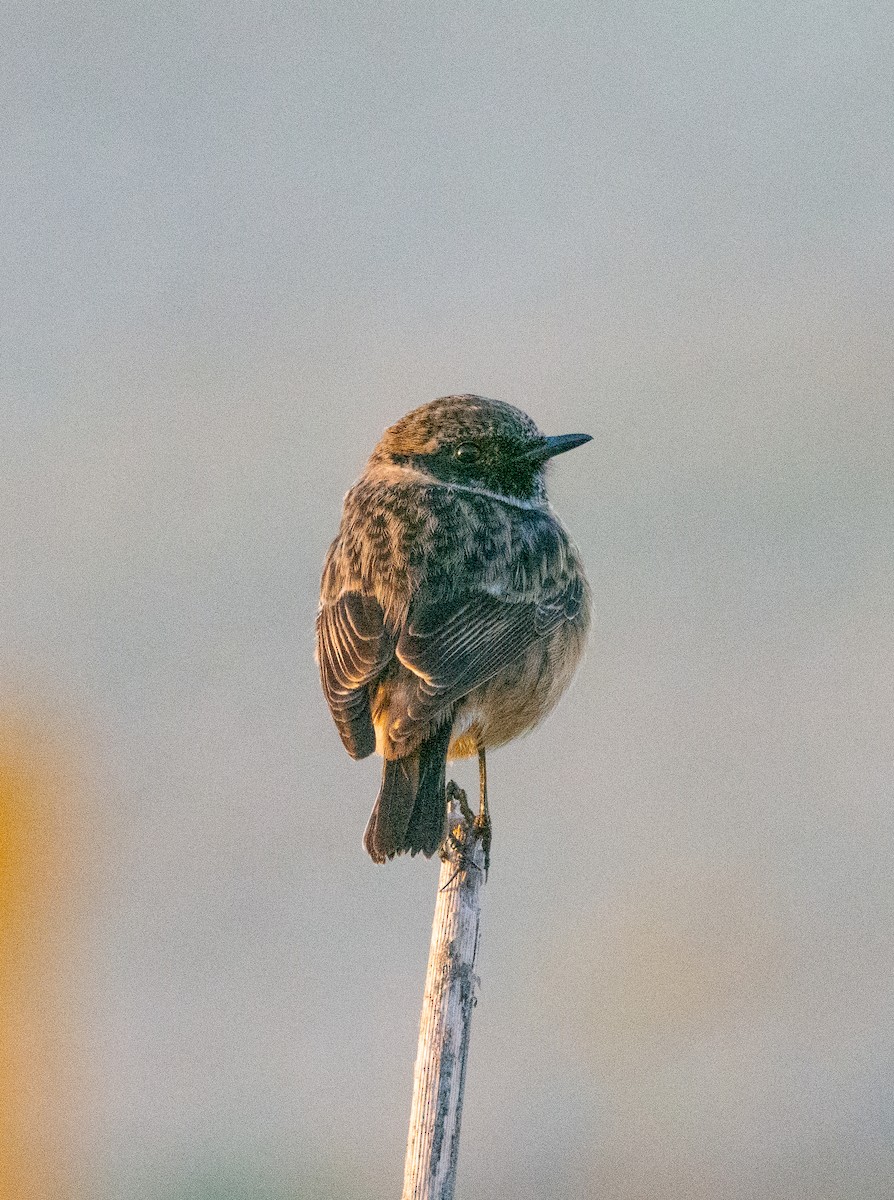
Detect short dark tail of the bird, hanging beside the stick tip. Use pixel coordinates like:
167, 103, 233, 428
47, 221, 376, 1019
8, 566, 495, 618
364, 721, 452, 863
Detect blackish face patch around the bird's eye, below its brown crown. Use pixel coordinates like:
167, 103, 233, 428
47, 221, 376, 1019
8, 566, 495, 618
395, 437, 542, 500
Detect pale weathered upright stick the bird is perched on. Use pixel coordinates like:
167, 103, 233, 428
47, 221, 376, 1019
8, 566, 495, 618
402, 781, 485, 1200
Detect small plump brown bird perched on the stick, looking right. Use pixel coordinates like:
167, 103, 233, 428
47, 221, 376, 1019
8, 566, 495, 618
317, 396, 590, 863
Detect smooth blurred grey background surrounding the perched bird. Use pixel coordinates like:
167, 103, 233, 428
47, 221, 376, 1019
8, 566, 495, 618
0, 0, 894, 1200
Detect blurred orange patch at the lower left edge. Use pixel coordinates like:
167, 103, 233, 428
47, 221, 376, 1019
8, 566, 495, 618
0, 709, 80, 1200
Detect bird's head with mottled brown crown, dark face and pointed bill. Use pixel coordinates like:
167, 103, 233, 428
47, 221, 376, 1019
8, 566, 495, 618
371, 396, 590, 502
